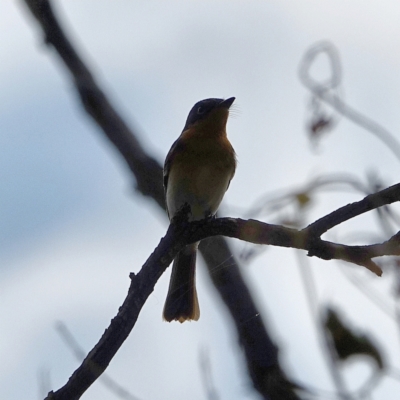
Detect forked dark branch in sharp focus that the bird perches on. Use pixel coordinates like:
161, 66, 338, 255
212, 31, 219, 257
42, 179, 400, 400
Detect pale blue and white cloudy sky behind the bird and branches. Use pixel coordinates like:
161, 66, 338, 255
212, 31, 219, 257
0, 0, 400, 400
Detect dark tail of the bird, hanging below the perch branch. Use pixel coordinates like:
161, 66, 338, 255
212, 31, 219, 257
163, 243, 200, 323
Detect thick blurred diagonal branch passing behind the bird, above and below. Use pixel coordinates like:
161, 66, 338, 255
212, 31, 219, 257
23, 0, 298, 400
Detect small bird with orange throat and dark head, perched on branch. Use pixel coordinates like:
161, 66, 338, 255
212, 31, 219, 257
163, 97, 237, 323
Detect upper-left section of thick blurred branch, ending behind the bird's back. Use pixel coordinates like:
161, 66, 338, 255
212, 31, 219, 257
21, 0, 164, 208
